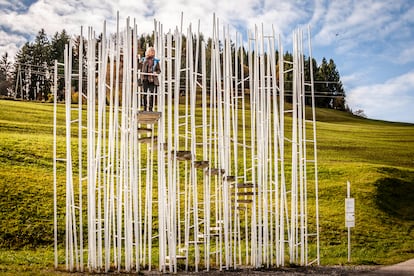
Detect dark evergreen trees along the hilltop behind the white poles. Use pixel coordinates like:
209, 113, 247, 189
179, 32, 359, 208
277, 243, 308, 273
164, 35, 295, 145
0, 29, 348, 110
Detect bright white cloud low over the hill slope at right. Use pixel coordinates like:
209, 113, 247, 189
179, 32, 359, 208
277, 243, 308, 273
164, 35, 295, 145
347, 71, 414, 123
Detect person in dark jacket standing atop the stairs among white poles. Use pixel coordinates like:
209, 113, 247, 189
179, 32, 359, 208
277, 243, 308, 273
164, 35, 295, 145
141, 47, 161, 111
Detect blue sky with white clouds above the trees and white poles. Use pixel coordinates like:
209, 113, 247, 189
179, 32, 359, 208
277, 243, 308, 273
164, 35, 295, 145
0, 0, 414, 123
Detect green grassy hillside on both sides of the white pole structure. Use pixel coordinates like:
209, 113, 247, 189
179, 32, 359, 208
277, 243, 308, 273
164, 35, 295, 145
0, 100, 414, 272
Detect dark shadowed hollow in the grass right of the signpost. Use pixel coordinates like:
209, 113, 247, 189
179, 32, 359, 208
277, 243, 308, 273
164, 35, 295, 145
374, 168, 414, 220
